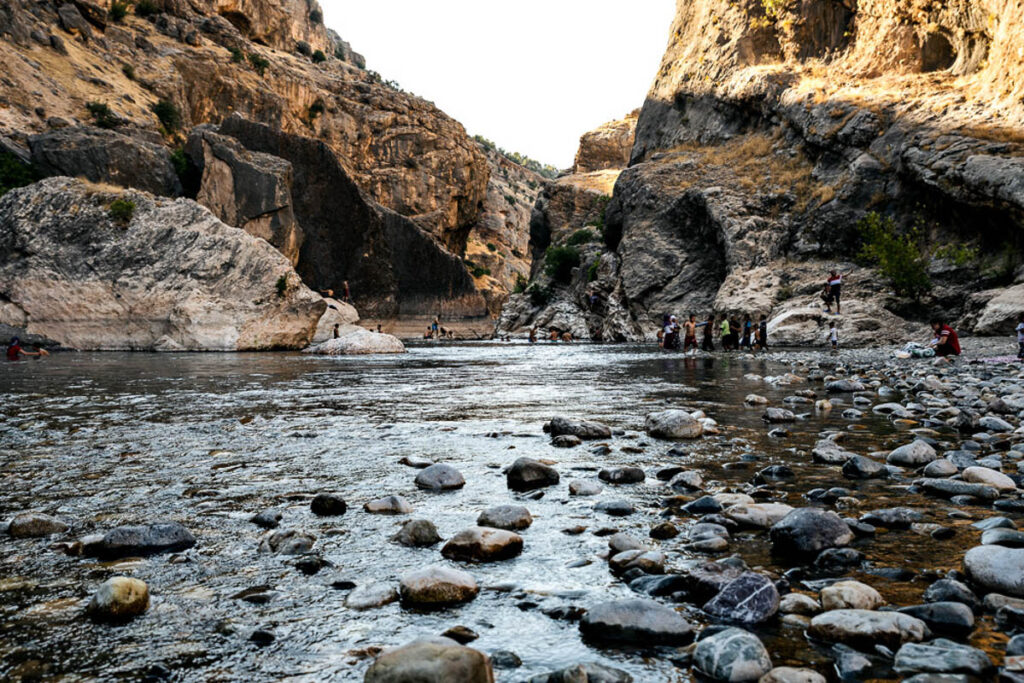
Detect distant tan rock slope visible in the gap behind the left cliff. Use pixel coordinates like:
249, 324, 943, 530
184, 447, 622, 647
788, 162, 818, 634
465, 145, 550, 317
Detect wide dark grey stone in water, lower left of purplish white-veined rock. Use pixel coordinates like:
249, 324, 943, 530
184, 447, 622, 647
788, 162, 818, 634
580, 598, 693, 645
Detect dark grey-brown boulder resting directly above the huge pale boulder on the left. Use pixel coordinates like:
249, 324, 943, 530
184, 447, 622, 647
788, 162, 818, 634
29, 126, 181, 197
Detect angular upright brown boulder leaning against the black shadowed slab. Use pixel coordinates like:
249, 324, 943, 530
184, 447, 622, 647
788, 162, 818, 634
186, 125, 303, 266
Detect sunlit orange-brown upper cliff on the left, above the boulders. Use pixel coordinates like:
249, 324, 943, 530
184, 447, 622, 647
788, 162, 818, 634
0, 0, 489, 312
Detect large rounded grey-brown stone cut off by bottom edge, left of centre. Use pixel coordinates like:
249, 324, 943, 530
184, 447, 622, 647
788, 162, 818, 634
362, 638, 495, 683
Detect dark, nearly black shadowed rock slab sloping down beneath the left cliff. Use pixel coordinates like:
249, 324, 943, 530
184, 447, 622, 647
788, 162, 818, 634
204, 116, 487, 318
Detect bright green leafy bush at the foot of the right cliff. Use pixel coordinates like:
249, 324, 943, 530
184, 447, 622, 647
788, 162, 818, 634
857, 211, 932, 299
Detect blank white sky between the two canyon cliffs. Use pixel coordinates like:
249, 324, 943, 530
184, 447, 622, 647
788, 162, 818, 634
321, 0, 675, 168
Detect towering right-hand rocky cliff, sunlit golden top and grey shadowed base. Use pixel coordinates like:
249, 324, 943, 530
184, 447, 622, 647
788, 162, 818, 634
500, 0, 1024, 343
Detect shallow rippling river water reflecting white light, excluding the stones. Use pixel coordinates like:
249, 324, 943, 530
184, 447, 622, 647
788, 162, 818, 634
0, 342, 1000, 681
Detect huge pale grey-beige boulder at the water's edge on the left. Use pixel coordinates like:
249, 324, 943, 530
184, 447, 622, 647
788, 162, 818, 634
0, 178, 325, 351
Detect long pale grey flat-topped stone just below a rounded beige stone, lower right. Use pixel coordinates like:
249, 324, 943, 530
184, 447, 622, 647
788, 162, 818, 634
807, 609, 928, 651
